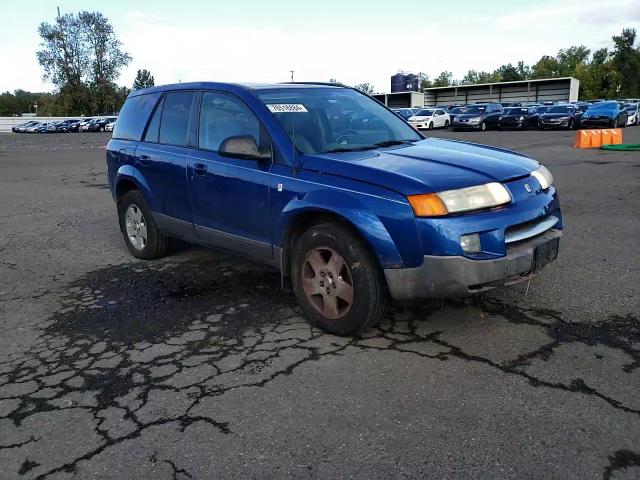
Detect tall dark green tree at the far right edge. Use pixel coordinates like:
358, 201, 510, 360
611, 28, 640, 98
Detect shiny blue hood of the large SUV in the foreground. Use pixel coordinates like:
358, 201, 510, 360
303, 138, 539, 195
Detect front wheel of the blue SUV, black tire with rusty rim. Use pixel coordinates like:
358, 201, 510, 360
291, 222, 388, 335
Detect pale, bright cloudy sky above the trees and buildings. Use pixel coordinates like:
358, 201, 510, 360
0, 0, 640, 92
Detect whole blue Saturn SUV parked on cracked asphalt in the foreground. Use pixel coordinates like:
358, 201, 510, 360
107, 82, 562, 335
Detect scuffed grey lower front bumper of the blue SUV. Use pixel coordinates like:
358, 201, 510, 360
384, 229, 562, 300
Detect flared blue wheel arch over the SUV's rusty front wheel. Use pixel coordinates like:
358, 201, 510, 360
275, 190, 403, 268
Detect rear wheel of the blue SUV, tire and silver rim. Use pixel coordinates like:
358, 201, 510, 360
118, 190, 169, 260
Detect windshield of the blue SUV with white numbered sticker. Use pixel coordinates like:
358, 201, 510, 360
256, 87, 422, 154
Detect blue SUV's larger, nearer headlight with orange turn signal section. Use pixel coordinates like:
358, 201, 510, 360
407, 182, 511, 217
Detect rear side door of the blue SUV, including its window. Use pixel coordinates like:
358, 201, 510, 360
134, 91, 195, 238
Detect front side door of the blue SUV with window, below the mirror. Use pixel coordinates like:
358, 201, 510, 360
188, 91, 273, 261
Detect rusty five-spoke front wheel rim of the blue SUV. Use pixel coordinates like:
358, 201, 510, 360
301, 247, 353, 320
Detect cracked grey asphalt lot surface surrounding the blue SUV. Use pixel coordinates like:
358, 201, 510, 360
0, 128, 640, 479
